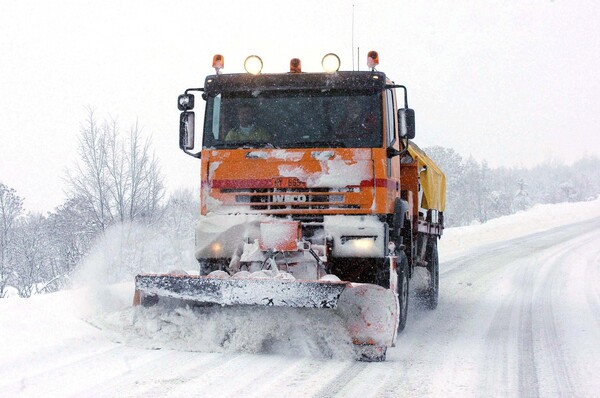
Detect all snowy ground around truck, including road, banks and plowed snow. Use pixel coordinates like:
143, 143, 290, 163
0, 200, 600, 397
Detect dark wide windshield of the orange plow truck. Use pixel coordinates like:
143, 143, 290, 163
202, 90, 384, 149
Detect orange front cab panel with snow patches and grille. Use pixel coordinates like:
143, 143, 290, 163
201, 148, 400, 214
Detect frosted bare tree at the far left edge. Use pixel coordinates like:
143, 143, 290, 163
0, 183, 23, 298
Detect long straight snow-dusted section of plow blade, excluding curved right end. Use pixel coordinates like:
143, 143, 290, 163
134, 275, 349, 308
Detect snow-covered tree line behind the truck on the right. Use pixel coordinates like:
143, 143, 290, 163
425, 146, 600, 227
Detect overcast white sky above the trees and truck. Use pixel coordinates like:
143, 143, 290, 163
0, 0, 600, 211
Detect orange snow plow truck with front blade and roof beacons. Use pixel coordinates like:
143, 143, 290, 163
134, 51, 445, 361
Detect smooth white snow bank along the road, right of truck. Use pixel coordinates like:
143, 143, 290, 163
439, 198, 600, 262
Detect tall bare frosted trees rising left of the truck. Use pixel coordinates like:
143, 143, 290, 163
67, 109, 164, 231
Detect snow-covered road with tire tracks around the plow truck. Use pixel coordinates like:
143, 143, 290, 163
0, 213, 600, 397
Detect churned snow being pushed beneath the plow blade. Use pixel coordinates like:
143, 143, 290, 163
98, 307, 353, 359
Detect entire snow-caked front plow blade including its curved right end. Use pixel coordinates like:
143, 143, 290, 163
134, 275, 399, 361
